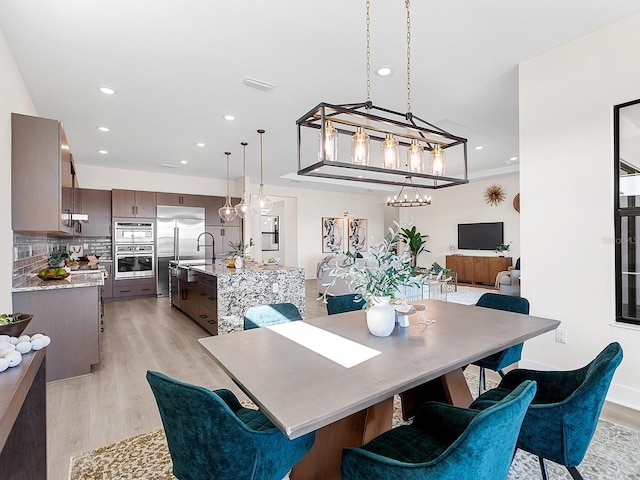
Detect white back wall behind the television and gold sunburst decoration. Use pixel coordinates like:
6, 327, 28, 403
397, 175, 520, 267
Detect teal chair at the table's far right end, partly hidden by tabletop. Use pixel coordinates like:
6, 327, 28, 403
473, 293, 529, 395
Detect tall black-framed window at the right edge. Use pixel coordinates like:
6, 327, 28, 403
613, 100, 640, 325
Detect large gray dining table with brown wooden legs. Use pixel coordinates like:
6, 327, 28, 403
199, 300, 560, 480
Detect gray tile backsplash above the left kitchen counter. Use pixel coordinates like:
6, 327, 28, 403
13, 233, 112, 285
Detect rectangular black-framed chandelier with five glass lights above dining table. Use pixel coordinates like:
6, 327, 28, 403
296, 101, 469, 189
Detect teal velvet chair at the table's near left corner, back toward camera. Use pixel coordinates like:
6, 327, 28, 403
147, 371, 315, 480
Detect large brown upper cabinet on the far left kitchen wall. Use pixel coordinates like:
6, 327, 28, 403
11, 113, 74, 235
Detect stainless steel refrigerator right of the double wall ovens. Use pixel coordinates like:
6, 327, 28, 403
156, 206, 206, 297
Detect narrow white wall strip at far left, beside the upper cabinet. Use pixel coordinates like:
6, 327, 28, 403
0, 30, 37, 312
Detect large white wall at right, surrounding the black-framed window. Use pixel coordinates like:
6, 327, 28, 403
520, 15, 640, 409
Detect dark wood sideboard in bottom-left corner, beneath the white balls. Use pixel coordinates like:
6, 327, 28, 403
0, 349, 47, 480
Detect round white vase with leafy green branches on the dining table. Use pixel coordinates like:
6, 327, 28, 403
323, 222, 423, 337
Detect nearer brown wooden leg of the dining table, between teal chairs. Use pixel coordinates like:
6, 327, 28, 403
289, 397, 393, 480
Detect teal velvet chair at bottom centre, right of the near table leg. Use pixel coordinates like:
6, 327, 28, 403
340, 381, 536, 480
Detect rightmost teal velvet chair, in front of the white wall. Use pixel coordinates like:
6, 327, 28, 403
470, 342, 622, 480
